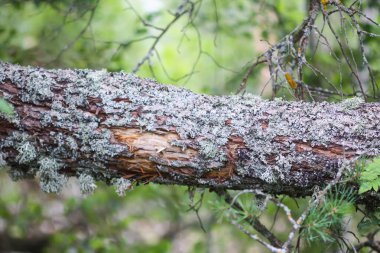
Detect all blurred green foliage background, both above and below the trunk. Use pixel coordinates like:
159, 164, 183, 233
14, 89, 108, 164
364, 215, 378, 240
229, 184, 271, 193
0, 0, 380, 253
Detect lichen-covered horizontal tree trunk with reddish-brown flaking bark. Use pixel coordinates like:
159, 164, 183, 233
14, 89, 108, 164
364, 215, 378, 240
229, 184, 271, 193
0, 63, 380, 196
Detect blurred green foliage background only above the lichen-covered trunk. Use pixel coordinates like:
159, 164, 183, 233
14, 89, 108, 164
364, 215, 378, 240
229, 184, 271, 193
0, 0, 380, 99
